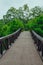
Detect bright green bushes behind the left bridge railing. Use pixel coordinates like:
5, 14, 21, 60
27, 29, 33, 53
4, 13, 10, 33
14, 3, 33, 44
0, 19, 24, 37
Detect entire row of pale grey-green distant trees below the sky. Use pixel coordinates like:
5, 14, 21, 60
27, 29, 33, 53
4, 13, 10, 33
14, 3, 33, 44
3, 4, 43, 23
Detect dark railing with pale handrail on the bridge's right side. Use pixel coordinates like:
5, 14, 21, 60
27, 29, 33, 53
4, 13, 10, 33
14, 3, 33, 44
31, 30, 43, 60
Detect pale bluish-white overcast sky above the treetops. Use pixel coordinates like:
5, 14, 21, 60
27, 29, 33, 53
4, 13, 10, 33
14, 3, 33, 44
0, 0, 43, 19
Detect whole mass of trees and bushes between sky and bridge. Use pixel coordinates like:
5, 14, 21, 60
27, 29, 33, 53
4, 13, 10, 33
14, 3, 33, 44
0, 4, 43, 37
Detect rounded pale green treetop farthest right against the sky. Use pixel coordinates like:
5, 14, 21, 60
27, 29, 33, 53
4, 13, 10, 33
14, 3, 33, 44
30, 6, 43, 17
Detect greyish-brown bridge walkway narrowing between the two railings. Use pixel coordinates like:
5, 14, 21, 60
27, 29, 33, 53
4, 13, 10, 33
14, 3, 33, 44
0, 31, 43, 65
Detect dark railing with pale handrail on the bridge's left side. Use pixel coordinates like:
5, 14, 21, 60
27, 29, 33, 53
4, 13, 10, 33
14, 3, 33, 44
0, 29, 21, 55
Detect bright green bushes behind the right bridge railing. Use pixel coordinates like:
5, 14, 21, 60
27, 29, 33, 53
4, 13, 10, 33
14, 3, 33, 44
27, 14, 43, 37
